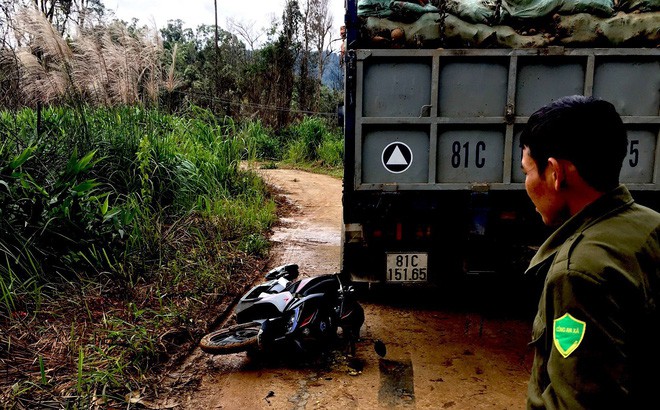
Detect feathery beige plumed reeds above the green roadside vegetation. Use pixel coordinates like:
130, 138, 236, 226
8, 7, 162, 106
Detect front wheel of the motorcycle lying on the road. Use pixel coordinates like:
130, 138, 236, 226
199, 322, 261, 354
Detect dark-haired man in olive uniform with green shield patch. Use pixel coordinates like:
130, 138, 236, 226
521, 96, 660, 409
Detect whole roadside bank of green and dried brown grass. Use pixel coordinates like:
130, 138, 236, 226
0, 107, 276, 408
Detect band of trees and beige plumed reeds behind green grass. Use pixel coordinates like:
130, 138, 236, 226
0, 0, 343, 129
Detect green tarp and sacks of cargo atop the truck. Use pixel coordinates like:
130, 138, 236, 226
358, 0, 660, 48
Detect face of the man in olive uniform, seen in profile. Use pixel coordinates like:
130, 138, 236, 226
521, 147, 565, 226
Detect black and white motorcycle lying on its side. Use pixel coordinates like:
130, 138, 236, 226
199, 264, 364, 354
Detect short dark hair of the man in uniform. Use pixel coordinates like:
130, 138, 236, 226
520, 95, 628, 192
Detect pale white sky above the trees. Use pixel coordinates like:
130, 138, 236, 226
109, 0, 344, 39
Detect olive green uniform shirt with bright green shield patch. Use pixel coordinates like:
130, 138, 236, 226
527, 186, 660, 409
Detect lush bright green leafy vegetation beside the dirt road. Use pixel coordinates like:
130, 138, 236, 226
0, 108, 274, 310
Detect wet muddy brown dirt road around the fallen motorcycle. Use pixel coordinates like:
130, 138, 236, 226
163, 169, 533, 410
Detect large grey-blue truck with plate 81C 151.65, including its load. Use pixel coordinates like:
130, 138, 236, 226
341, 0, 660, 285
